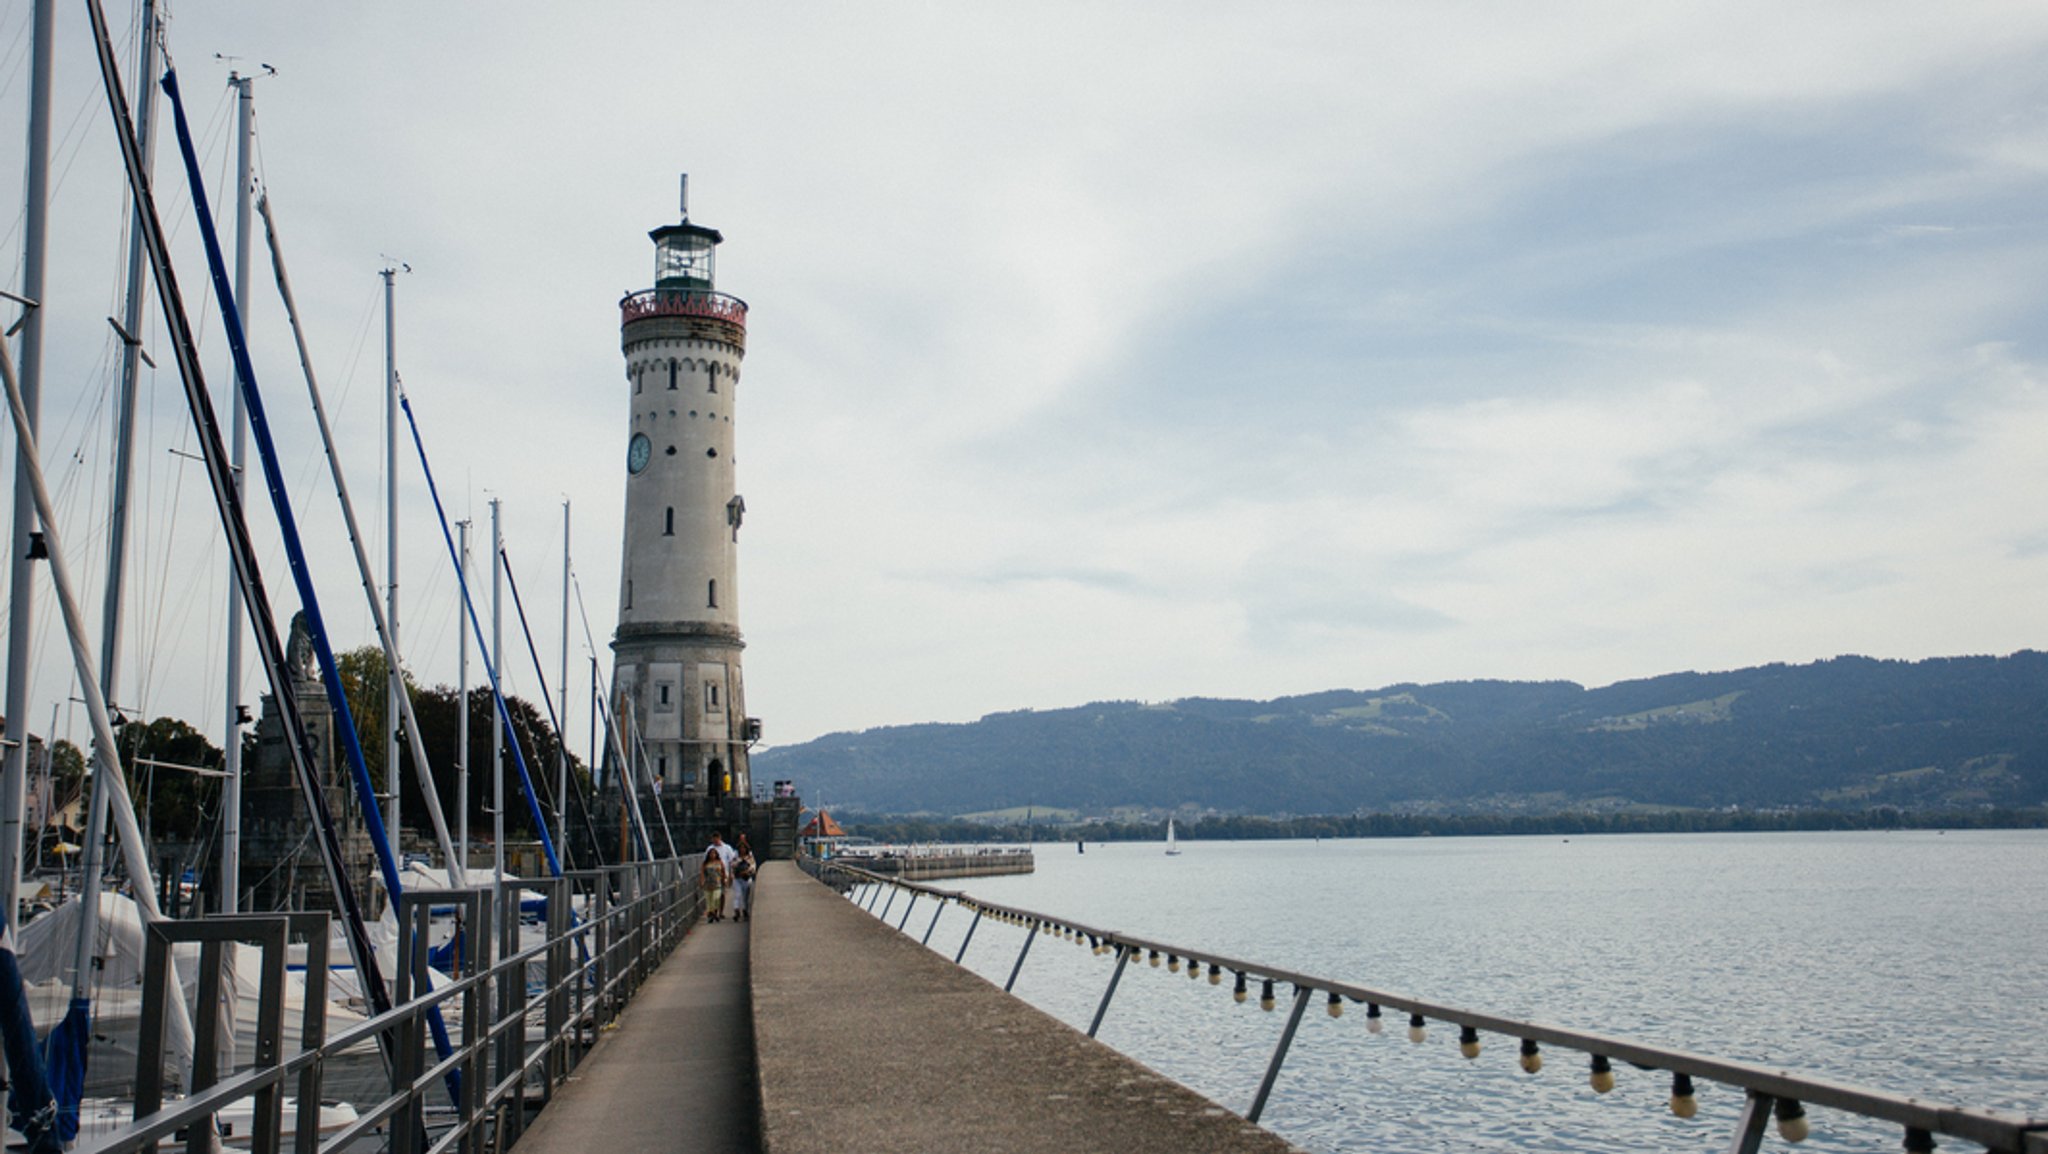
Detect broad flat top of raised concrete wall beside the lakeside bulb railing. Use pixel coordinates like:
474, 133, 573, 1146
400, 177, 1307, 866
749, 861, 1292, 1154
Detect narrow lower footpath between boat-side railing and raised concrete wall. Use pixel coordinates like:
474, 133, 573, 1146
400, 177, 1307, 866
518, 905, 762, 1154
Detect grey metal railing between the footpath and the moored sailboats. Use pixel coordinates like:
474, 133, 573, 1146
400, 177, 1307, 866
78, 861, 702, 1154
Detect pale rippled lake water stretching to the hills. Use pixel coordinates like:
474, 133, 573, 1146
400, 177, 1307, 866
868, 830, 2048, 1152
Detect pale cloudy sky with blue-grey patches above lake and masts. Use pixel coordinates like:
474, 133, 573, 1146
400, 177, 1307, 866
0, 0, 2048, 748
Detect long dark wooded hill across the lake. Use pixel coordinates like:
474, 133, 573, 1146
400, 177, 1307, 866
754, 650, 2048, 814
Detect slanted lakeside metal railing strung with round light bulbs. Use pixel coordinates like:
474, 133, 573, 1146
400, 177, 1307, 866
801, 857, 2048, 1154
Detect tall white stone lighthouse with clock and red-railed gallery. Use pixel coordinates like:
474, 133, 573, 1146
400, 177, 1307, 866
612, 176, 760, 822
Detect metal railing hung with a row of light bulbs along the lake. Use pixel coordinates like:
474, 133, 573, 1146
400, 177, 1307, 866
803, 859, 2048, 1154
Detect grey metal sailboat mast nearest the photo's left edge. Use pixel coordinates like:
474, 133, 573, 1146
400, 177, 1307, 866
0, 0, 57, 924
